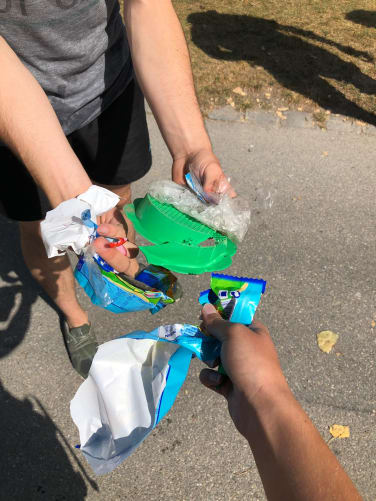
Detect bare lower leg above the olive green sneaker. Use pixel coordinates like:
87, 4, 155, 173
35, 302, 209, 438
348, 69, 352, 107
20, 221, 88, 328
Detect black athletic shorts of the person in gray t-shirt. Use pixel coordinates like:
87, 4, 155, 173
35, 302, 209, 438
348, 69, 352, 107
0, 80, 151, 221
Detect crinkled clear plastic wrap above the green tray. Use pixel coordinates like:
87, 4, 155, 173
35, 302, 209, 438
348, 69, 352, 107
149, 180, 251, 242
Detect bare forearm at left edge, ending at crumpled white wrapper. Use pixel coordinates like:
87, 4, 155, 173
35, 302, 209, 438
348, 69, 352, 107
0, 37, 91, 206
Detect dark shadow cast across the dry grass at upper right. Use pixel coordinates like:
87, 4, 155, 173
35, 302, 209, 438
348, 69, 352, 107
187, 11, 376, 125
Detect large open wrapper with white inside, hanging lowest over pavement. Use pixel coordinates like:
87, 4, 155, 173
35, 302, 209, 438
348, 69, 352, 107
70, 339, 178, 475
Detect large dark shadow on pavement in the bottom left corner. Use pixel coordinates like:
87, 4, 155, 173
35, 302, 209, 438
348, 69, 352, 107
0, 382, 93, 501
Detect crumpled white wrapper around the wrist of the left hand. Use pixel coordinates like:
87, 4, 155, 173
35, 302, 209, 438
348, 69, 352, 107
41, 185, 120, 257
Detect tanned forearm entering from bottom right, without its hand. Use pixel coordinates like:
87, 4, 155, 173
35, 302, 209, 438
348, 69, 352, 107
247, 388, 361, 501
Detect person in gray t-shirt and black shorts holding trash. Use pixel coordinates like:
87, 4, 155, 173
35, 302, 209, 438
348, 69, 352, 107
0, 0, 231, 374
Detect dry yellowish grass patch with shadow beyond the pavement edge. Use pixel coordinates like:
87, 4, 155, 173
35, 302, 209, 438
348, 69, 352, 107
174, 0, 376, 124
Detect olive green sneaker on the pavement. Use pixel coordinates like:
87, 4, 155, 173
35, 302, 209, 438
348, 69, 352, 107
63, 323, 98, 378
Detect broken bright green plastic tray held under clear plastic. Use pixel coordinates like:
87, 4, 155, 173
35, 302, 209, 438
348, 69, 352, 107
124, 195, 236, 274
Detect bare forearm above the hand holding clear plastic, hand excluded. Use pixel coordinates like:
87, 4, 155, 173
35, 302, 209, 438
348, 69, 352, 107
124, 0, 211, 160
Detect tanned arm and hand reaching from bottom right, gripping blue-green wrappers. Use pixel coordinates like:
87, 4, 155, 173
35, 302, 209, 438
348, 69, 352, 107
200, 305, 362, 501
